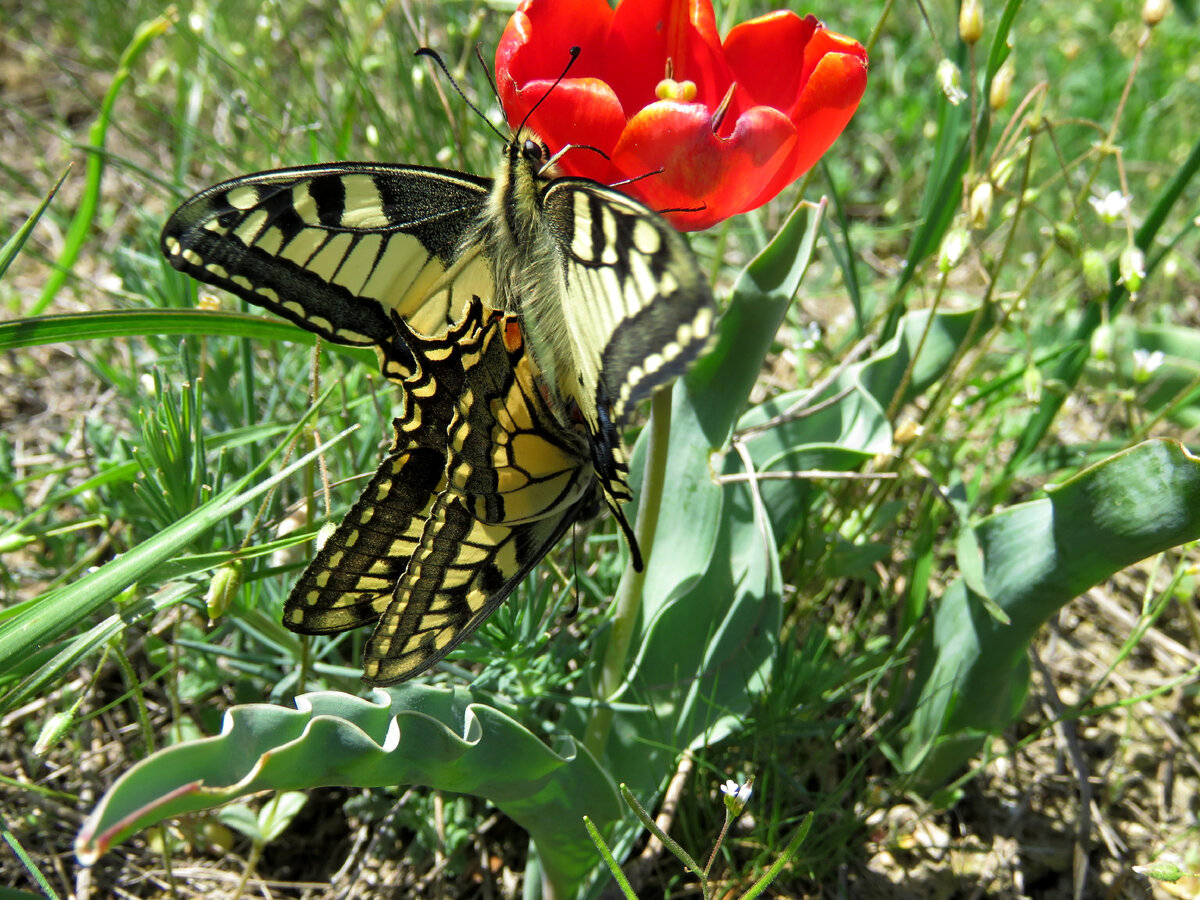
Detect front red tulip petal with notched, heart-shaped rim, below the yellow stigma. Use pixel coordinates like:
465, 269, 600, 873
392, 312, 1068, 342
613, 101, 796, 230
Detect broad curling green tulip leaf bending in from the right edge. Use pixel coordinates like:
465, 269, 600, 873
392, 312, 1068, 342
900, 440, 1200, 785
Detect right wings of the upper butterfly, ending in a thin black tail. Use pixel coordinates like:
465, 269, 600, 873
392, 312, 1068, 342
511, 179, 714, 542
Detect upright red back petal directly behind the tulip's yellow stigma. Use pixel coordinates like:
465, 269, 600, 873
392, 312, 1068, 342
605, 0, 731, 114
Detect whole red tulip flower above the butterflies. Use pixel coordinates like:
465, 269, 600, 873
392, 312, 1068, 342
496, 0, 866, 230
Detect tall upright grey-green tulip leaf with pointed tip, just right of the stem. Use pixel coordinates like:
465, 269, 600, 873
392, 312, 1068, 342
585, 204, 824, 857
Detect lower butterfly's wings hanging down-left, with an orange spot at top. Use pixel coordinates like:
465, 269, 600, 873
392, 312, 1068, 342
284, 301, 595, 685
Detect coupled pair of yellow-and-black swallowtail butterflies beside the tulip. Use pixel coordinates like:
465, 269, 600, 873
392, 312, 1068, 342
162, 132, 714, 684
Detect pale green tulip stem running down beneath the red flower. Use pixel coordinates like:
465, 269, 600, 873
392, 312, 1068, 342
583, 388, 672, 758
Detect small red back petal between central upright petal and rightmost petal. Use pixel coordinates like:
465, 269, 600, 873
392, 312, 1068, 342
724, 11, 817, 113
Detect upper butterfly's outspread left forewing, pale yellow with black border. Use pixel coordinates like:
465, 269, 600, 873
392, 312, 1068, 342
162, 163, 494, 377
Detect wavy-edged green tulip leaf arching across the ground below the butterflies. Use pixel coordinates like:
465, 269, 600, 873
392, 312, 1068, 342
76, 684, 620, 896
